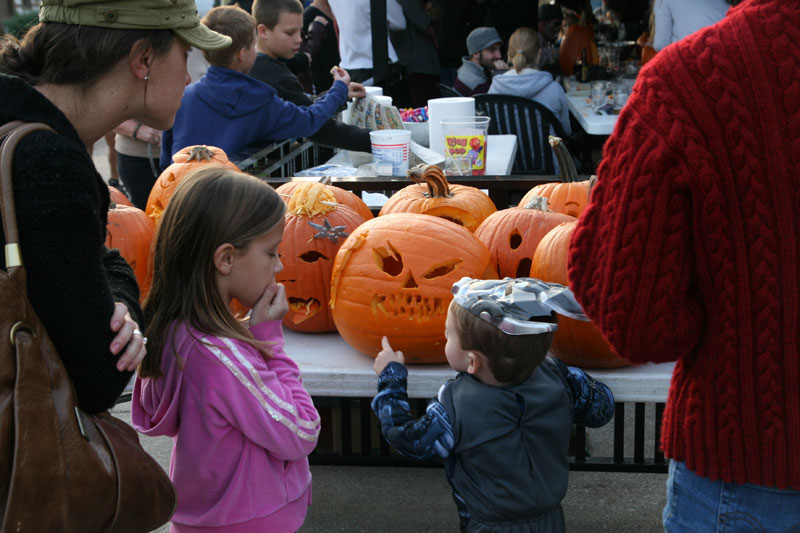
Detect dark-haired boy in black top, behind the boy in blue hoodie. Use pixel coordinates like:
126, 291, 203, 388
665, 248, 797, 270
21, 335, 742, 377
250, 0, 371, 152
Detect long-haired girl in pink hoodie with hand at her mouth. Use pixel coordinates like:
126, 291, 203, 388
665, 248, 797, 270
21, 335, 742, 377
131, 166, 320, 533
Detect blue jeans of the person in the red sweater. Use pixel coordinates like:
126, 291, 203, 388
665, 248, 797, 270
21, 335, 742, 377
662, 460, 800, 533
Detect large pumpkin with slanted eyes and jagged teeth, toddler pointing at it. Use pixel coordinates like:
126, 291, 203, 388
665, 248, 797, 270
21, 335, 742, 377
330, 213, 496, 363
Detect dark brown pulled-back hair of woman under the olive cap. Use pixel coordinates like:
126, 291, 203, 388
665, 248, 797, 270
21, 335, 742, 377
0, 22, 176, 87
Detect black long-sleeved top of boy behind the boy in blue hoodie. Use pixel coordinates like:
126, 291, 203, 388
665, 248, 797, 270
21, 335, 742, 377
250, 54, 372, 152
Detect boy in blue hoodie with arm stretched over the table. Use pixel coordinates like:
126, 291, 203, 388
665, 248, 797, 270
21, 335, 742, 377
161, 6, 350, 169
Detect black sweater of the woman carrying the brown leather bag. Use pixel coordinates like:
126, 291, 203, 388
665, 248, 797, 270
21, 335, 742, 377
0, 74, 144, 412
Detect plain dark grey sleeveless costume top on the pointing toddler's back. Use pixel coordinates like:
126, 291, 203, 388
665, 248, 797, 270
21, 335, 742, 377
439, 358, 573, 533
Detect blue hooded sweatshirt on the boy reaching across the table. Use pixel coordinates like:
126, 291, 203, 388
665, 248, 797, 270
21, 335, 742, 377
160, 66, 347, 170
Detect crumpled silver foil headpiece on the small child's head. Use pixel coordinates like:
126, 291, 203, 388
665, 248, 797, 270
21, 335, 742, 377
453, 277, 589, 335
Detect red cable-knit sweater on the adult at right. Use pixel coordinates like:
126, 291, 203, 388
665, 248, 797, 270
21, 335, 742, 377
569, 0, 800, 489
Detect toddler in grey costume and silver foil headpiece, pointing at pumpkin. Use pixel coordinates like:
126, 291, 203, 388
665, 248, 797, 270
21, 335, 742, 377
372, 278, 614, 533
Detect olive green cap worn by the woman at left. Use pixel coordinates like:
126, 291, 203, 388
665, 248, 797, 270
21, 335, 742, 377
39, 0, 231, 50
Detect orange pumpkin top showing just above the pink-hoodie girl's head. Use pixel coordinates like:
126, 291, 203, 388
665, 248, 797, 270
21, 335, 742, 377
145, 145, 239, 224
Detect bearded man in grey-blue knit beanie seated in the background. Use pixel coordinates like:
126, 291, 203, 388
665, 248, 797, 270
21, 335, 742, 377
453, 26, 508, 96
